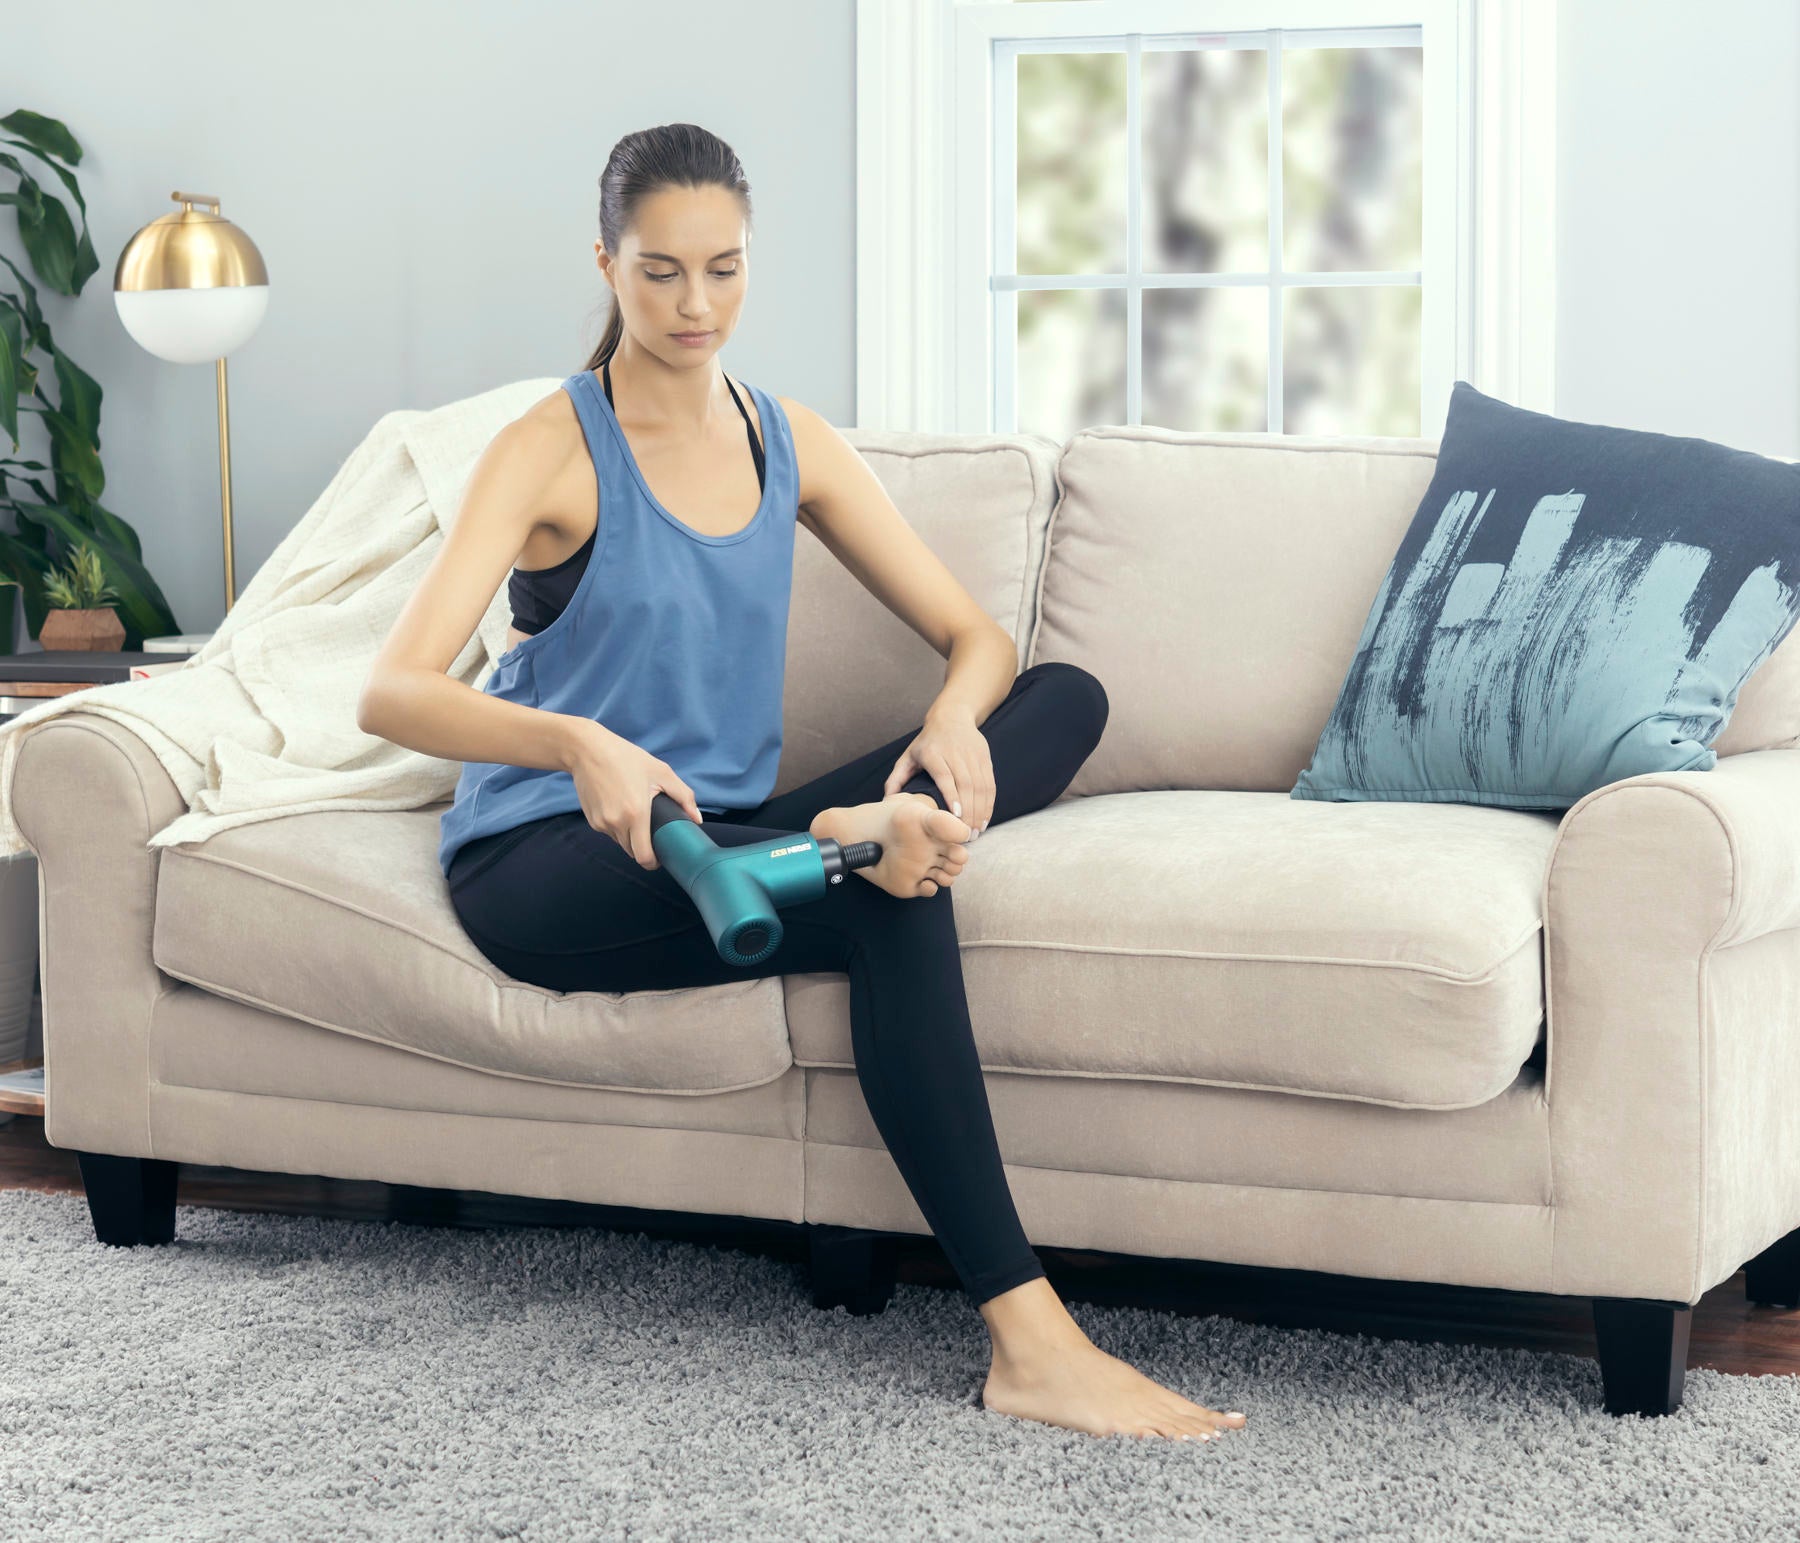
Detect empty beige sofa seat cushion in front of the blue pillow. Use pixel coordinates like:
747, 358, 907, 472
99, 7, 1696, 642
788, 790, 1559, 1109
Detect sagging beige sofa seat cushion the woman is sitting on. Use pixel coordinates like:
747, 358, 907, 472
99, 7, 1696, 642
151, 801, 792, 1093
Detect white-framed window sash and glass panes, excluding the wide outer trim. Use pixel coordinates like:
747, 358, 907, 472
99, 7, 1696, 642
988, 27, 1424, 439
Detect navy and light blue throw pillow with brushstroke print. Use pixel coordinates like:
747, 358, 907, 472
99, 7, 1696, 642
1291, 380, 1800, 808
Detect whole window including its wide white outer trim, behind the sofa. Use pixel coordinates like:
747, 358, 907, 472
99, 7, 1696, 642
857, 0, 1555, 441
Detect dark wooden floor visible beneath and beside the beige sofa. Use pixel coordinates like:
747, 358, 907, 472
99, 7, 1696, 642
0, 1114, 1800, 1376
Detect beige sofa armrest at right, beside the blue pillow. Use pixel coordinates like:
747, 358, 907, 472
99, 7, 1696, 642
1543, 749, 1800, 1302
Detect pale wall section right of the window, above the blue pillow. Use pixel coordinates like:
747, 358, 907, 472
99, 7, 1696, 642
1557, 0, 1800, 457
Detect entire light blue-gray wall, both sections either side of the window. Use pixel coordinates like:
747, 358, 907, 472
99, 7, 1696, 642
0, 0, 1800, 632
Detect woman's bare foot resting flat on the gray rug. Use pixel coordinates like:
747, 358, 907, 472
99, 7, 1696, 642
981, 1278, 1246, 1440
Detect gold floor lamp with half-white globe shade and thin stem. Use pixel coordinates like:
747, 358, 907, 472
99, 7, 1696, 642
113, 193, 268, 610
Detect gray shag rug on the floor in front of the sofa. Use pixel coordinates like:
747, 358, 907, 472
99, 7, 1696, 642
0, 1190, 1800, 1543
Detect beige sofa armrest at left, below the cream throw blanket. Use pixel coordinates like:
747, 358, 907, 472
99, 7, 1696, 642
13, 708, 187, 1158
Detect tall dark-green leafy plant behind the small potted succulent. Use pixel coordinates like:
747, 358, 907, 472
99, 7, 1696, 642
0, 108, 182, 652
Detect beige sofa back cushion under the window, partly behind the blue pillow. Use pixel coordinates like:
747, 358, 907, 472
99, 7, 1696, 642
1026, 425, 1800, 796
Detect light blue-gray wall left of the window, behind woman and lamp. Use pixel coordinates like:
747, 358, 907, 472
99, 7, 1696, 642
0, 0, 855, 632
